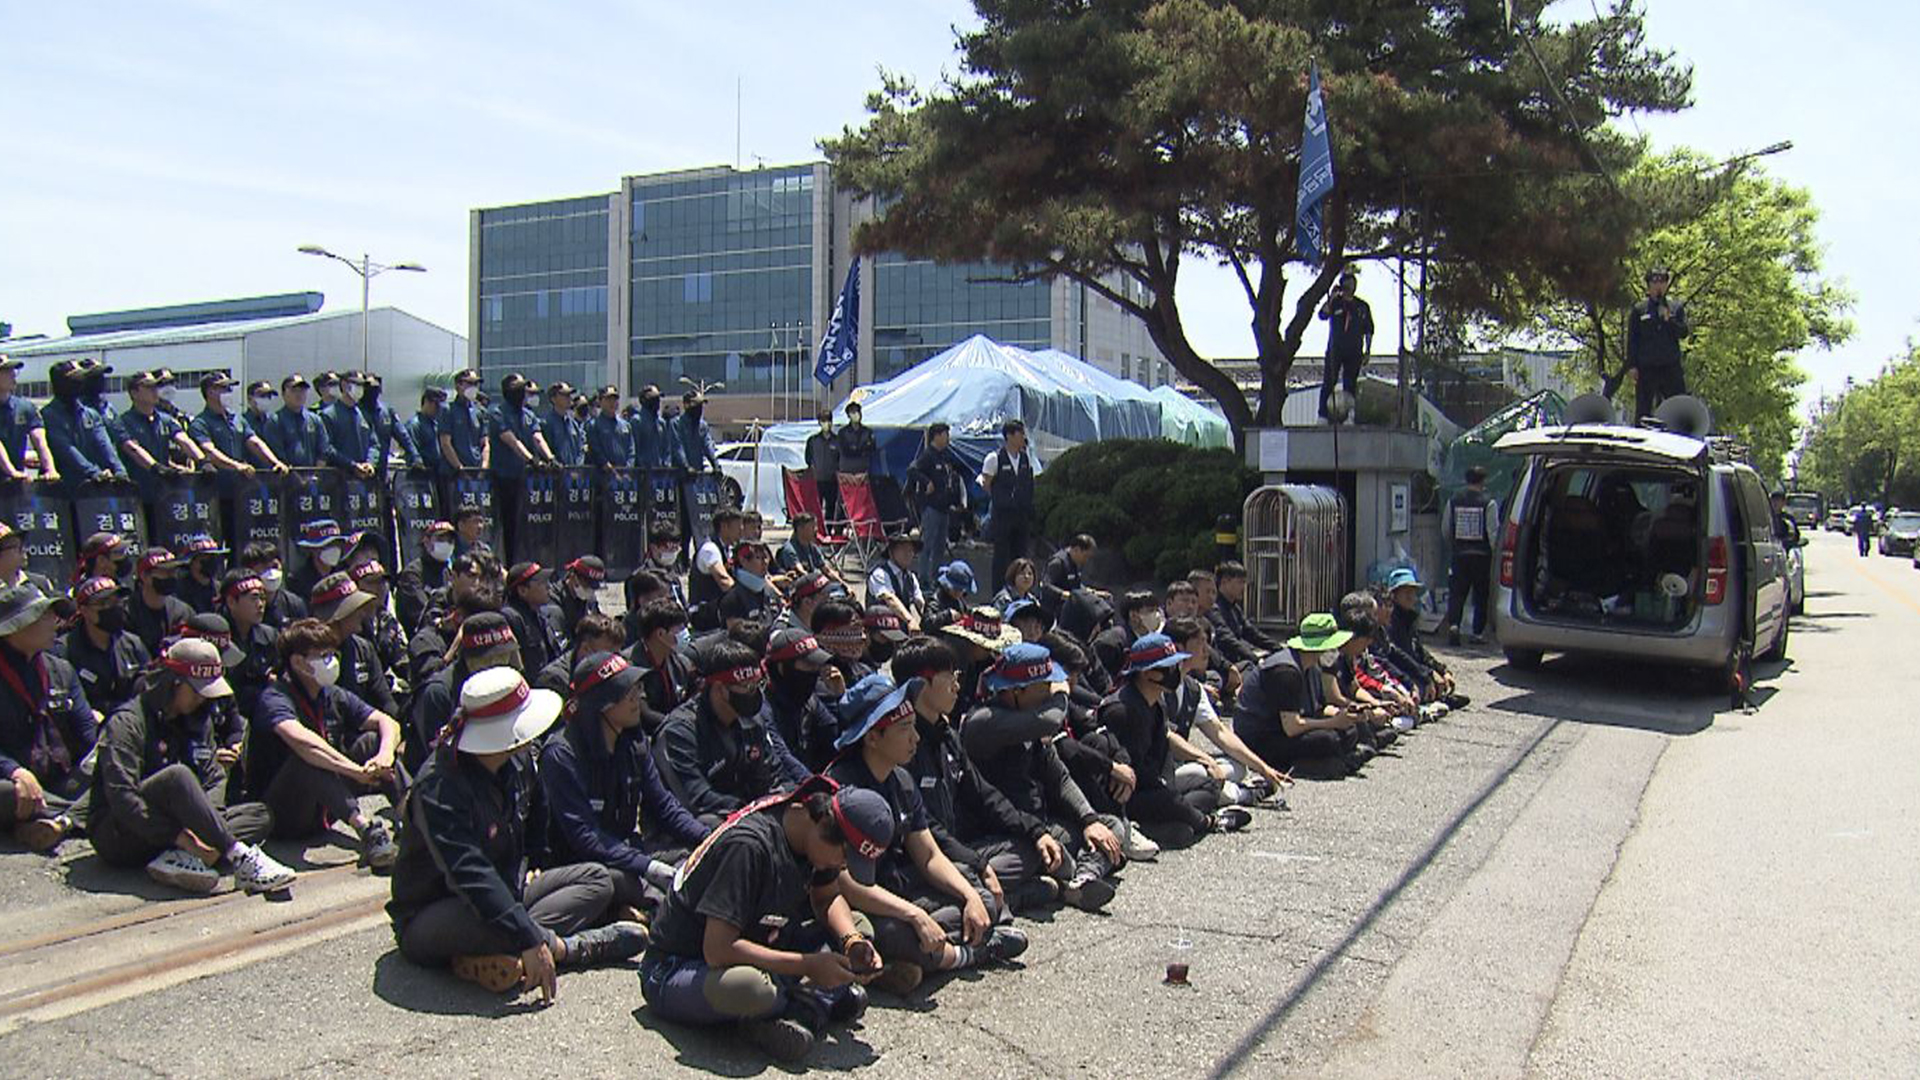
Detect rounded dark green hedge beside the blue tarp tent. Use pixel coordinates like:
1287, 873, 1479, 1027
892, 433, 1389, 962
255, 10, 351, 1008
1035, 438, 1260, 580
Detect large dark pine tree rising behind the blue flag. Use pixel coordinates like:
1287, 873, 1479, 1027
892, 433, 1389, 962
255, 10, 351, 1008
822, 0, 1692, 438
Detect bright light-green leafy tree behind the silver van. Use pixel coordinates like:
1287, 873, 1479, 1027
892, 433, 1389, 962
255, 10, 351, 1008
1530, 150, 1853, 479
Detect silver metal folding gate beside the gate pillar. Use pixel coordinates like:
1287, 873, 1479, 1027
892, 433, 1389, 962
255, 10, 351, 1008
1240, 484, 1346, 632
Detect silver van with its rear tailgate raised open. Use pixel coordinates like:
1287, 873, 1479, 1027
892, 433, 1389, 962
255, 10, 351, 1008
1492, 423, 1789, 696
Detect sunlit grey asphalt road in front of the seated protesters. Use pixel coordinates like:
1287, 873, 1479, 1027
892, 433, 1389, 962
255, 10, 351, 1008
0, 536, 1920, 1076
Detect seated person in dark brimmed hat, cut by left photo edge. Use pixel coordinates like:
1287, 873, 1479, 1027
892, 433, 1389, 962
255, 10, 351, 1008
0, 586, 100, 851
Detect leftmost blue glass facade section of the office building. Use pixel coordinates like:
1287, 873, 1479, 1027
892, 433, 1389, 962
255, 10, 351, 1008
472, 194, 609, 388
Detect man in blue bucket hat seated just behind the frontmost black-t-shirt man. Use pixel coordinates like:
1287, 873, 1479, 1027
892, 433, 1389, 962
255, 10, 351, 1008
826, 675, 1027, 986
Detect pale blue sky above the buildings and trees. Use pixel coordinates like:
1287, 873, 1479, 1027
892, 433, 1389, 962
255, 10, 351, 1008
0, 0, 1920, 411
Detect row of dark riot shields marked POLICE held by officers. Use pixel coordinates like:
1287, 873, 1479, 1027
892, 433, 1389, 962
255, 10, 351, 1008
0, 465, 722, 582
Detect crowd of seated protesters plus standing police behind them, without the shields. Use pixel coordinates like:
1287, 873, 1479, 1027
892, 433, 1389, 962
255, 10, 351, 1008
0, 363, 1465, 1061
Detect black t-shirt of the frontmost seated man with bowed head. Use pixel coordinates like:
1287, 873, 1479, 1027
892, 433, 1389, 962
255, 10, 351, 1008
651, 803, 837, 957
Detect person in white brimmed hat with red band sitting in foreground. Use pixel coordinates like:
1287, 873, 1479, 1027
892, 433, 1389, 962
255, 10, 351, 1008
386, 667, 647, 1001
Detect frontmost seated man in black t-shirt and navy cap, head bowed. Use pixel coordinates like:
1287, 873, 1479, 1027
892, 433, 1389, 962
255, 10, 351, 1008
639, 778, 893, 1063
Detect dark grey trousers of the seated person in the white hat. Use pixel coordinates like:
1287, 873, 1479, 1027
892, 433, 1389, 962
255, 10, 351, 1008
394, 863, 614, 967
